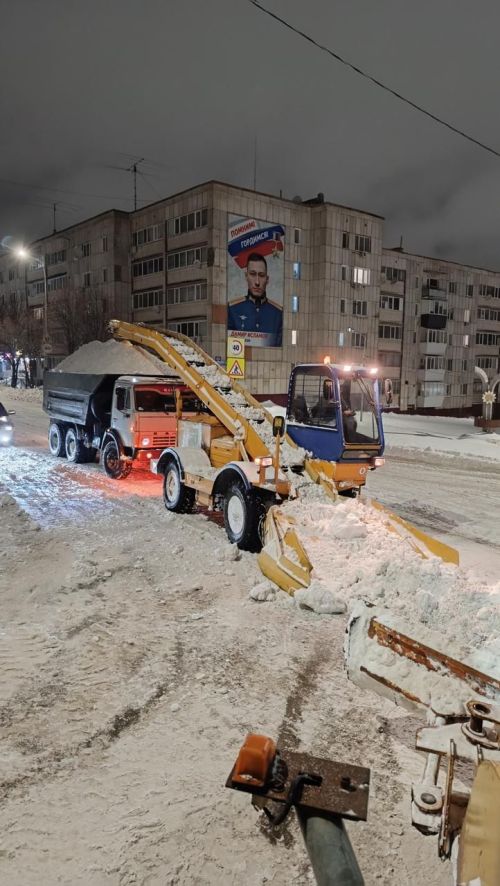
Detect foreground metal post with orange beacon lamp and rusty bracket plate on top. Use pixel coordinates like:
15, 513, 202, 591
226, 734, 370, 886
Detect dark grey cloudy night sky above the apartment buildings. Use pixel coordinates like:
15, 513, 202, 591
0, 0, 500, 269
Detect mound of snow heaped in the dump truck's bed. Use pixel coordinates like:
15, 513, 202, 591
55, 339, 175, 376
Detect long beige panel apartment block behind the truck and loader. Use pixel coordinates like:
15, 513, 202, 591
0, 182, 500, 411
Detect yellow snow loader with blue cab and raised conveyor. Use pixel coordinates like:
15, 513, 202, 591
110, 320, 453, 594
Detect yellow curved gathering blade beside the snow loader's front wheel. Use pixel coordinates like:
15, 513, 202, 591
257, 505, 312, 596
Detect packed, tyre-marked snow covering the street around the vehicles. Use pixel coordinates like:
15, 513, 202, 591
0, 387, 500, 886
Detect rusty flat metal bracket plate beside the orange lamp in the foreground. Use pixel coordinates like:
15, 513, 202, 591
226, 751, 370, 821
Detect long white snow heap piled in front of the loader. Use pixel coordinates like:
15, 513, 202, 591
283, 499, 500, 672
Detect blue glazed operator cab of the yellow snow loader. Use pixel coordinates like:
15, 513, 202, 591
287, 364, 384, 461
